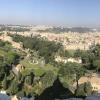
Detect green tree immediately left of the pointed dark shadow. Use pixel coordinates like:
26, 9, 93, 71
32, 71, 56, 95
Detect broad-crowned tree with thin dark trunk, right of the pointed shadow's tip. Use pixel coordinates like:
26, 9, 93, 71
59, 62, 85, 93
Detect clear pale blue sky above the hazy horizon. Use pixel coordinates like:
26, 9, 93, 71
0, 0, 100, 27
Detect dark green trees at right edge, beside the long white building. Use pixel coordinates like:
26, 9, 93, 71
74, 44, 100, 72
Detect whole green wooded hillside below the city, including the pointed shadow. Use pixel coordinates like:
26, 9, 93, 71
0, 35, 100, 100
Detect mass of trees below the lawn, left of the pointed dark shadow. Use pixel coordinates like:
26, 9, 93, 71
0, 68, 56, 97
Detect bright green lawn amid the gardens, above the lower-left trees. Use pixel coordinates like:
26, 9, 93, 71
20, 60, 58, 76
